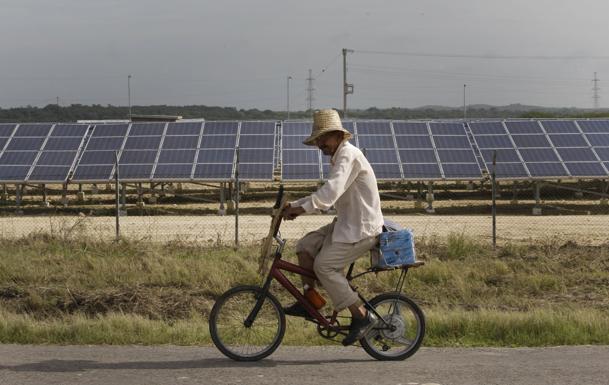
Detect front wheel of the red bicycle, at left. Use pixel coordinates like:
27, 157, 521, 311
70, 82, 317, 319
209, 286, 285, 361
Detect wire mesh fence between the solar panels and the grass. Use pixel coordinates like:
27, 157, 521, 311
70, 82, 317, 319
0, 180, 609, 247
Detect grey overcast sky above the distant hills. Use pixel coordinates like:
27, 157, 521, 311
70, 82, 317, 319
0, 0, 609, 110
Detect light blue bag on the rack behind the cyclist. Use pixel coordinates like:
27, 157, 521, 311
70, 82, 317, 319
377, 220, 416, 267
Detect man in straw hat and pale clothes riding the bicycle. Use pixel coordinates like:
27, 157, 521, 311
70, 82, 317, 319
283, 109, 383, 345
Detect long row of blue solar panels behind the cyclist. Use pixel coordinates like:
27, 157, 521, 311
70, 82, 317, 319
0, 120, 609, 183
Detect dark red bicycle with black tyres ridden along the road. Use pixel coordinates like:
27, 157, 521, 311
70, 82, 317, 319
209, 186, 425, 361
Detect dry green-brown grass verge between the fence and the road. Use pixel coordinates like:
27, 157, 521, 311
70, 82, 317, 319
0, 234, 609, 346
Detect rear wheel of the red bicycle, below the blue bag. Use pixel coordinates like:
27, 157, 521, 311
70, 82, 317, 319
360, 293, 425, 361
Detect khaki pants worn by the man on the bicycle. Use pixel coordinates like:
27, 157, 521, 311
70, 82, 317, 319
296, 220, 378, 311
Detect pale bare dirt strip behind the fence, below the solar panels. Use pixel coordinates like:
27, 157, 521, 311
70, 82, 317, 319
0, 215, 609, 245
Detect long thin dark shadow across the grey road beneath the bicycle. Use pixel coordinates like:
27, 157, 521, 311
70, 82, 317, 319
0, 358, 370, 372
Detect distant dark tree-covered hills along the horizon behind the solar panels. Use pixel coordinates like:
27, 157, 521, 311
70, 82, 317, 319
0, 104, 609, 122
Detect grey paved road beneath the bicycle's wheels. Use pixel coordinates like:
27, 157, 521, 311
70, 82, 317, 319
0, 345, 609, 385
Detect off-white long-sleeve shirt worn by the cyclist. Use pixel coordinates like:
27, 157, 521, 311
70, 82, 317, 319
291, 140, 383, 243
